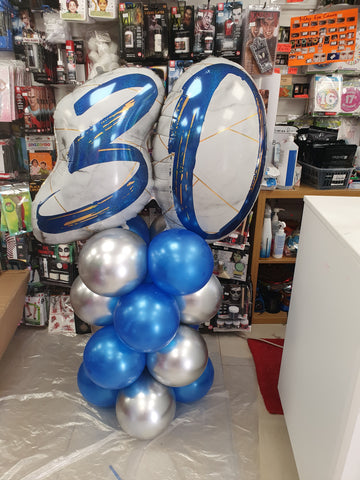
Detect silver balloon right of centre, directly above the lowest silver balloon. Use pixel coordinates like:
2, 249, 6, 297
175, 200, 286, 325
147, 325, 208, 387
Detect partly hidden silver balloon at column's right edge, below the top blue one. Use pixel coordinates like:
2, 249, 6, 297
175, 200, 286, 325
176, 275, 223, 325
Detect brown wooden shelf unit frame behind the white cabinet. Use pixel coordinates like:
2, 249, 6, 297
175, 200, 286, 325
250, 185, 360, 324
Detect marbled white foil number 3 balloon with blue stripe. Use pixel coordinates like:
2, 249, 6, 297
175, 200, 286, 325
32, 67, 164, 244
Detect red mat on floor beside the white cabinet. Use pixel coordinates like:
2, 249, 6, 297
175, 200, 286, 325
248, 338, 284, 415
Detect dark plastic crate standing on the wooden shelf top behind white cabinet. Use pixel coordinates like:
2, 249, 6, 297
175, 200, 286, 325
301, 162, 353, 190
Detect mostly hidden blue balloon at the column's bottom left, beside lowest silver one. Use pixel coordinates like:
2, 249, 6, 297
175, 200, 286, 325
77, 363, 119, 408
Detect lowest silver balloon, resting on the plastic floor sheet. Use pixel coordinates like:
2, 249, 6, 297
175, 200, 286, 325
116, 369, 176, 440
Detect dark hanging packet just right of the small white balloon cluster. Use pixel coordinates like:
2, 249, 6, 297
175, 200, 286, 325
119, 2, 145, 62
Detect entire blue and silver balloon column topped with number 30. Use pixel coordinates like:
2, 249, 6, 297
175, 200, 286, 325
32, 57, 266, 439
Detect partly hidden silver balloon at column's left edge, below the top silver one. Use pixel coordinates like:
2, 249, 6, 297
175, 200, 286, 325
70, 275, 118, 326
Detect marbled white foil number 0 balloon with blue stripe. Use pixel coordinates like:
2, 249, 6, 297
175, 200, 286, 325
153, 57, 266, 241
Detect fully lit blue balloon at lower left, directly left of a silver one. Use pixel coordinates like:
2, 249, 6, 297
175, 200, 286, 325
83, 325, 146, 390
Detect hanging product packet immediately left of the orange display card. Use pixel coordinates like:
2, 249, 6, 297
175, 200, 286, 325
241, 6, 280, 75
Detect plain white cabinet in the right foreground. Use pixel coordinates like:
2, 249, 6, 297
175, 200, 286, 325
279, 196, 360, 480
